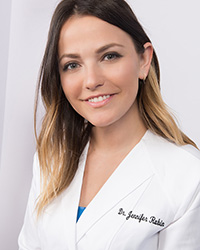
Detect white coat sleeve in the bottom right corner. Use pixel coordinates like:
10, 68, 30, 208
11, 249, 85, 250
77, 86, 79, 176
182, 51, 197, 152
158, 184, 200, 250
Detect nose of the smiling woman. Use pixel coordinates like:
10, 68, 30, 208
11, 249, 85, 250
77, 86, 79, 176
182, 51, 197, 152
84, 65, 104, 91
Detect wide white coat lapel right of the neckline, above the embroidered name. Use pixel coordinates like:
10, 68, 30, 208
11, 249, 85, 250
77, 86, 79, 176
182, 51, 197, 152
77, 136, 154, 242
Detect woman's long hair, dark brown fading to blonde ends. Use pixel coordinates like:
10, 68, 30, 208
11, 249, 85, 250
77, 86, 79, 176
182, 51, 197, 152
35, 0, 196, 214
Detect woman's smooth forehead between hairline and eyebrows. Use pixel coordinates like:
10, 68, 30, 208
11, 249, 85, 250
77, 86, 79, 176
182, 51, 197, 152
59, 16, 133, 53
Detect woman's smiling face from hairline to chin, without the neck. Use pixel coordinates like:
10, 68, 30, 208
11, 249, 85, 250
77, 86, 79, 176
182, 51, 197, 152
58, 16, 152, 127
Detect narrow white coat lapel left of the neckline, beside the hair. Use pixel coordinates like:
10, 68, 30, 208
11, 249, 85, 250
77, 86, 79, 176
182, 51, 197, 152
62, 143, 89, 250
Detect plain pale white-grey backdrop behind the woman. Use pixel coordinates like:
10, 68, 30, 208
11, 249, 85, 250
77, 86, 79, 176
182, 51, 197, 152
0, 0, 200, 250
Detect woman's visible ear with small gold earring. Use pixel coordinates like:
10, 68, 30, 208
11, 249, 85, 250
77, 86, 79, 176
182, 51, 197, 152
139, 42, 153, 80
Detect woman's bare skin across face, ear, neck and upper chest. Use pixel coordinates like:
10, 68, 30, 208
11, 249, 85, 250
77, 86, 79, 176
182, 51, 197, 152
58, 16, 153, 206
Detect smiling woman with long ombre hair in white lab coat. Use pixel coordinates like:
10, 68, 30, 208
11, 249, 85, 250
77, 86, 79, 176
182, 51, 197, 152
19, 0, 200, 250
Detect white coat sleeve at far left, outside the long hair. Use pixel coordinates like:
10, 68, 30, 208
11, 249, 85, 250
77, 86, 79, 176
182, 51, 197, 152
18, 153, 41, 250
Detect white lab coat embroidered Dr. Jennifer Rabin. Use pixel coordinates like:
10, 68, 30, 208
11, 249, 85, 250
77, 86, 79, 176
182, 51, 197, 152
19, 131, 200, 250
